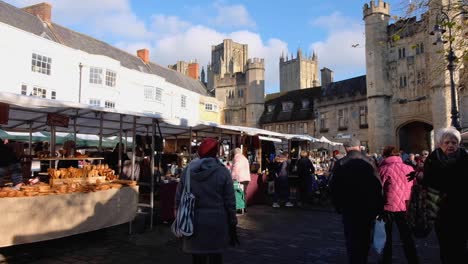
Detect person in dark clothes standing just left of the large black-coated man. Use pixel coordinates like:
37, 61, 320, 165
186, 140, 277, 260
296, 150, 315, 206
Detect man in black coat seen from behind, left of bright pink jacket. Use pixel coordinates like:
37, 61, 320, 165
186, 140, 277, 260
330, 138, 384, 264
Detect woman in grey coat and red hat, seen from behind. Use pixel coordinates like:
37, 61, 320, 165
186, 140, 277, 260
175, 138, 238, 264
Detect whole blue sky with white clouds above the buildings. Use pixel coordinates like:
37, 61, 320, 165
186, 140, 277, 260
6, 0, 410, 93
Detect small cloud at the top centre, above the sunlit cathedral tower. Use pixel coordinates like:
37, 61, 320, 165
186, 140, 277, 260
212, 3, 255, 28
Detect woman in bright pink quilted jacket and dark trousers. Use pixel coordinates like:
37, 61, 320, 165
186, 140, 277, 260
379, 146, 419, 263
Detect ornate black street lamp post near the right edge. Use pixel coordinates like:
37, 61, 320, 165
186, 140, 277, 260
430, 1, 467, 131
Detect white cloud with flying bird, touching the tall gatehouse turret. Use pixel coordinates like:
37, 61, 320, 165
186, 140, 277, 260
310, 12, 365, 81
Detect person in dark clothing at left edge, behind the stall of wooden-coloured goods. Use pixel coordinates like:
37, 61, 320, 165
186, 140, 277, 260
0, 139, 23, 189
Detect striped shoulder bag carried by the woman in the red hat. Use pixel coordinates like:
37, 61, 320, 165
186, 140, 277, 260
171, 166, 195, 238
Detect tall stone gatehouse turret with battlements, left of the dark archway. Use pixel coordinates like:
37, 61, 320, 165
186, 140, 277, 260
363, 0, 394, 152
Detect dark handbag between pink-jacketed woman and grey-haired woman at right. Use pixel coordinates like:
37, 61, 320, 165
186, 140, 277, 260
406, 184, 440, 238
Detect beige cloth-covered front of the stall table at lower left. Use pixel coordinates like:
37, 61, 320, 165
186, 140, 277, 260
0, 186, 138, 247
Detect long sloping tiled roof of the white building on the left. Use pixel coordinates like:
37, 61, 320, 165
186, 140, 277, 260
0, 1, 208, 95
